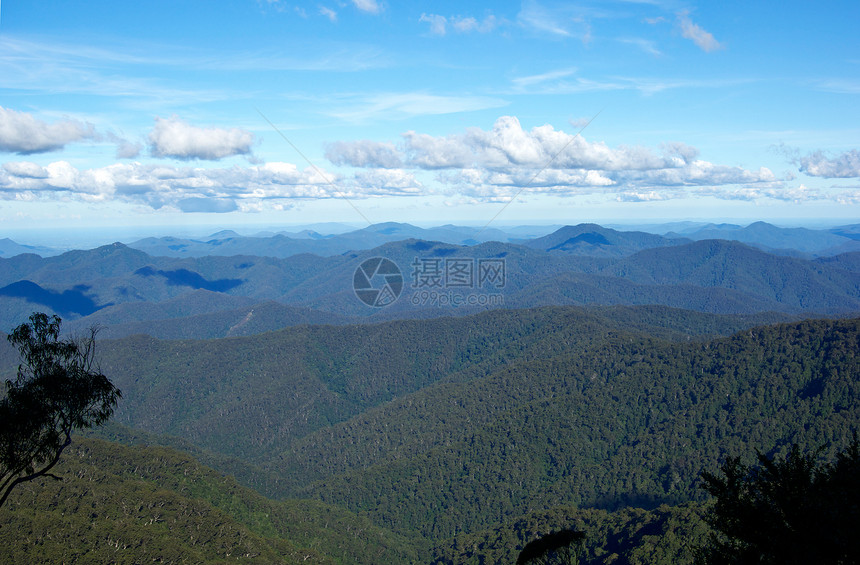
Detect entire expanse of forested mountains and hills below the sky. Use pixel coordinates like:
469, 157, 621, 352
0, 220, 860, 564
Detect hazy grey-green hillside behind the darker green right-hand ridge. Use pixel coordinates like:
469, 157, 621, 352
74, 308, 792, 472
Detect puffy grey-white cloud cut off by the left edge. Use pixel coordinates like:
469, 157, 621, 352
0, 106, 97, 155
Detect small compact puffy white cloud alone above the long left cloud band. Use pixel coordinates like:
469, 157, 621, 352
149, 116, 254, 160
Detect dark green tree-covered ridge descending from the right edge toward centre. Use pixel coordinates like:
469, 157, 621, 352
290, 320, 860, 538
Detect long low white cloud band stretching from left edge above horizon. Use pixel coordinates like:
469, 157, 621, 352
0, 161, 423, 213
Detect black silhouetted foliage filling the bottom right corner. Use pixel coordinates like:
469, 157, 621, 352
698, 435, 860, 564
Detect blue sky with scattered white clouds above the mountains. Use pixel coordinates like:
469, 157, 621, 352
0, 0, 860, 236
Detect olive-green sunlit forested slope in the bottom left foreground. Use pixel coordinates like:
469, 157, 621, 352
0, 439, 416, 564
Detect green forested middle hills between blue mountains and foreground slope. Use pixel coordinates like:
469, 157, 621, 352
0, 307, 860, 562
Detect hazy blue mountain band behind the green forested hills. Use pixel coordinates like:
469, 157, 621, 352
0, 224, 860, 338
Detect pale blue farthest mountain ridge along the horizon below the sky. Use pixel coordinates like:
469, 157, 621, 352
0, 222, 860, 258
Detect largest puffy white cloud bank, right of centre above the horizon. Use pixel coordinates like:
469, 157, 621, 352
326, 116, 787, 201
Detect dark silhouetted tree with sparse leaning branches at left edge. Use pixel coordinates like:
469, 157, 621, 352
0, 312, 121, 506
